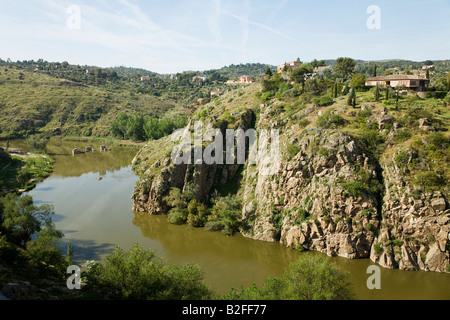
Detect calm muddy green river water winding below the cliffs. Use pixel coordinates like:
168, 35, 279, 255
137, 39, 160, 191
4, 140, 450, 300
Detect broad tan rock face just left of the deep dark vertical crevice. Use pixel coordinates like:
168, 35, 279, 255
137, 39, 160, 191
243, 130, 379, 259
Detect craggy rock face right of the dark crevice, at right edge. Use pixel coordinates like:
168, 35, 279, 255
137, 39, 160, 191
371, 158, 450, 272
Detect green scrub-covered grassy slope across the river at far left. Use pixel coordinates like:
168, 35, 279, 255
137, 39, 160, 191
0, 67, 187, 136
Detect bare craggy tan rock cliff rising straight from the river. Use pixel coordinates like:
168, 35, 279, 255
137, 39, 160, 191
133, 84, 450, 272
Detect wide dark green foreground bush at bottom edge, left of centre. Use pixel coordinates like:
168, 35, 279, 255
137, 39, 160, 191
82, 245, 213, 300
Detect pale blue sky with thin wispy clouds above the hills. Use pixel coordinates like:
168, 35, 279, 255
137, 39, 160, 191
0, 0, 450, 74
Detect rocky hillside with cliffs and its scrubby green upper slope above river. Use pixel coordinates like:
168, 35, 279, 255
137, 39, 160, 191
133, 85, 450, 272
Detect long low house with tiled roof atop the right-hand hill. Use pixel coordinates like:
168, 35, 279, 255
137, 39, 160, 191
366, 74, 430, 92
